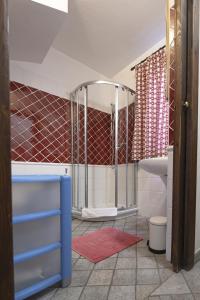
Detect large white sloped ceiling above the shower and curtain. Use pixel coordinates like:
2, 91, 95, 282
53, 0, 166, 77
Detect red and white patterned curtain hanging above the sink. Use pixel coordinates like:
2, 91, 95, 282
132, 48, 169, 160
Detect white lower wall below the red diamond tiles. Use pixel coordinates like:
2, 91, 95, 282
12, 161, 169, 217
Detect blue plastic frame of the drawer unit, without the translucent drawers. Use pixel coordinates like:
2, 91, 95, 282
12, 175, 72, 300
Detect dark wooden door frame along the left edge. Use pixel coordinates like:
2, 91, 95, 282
0, 0, 14, 300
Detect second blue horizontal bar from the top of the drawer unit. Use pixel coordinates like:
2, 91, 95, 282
13, 209, 61, 224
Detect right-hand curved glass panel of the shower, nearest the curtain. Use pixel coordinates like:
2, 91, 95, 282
115, 88, 136, 210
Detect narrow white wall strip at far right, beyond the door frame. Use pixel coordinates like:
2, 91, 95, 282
195, 4, 200, 252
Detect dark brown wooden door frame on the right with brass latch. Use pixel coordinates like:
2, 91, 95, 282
172, 0, 199, 272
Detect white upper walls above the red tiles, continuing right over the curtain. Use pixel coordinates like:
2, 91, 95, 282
10, 40, 165, 112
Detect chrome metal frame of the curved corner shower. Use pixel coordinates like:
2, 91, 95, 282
70, 80, 137, 218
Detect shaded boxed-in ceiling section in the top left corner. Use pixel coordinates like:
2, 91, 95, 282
9, 0, 66, 63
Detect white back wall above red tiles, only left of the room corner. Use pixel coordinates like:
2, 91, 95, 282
10, 47, 111, 111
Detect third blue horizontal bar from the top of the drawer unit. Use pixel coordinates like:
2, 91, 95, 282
14, 242, 61, 264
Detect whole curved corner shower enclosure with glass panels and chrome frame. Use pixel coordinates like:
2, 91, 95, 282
71, 81, 137, 219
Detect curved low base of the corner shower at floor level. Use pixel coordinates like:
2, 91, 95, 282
72, 207, 138, 222
